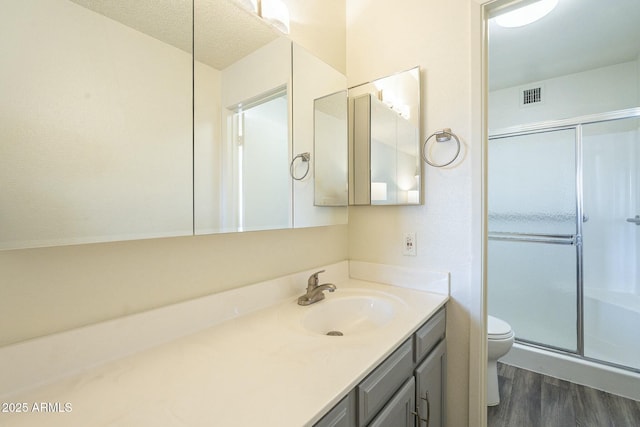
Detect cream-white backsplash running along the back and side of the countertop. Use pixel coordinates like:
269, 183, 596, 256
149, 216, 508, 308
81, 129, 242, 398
0, 261, 449, 399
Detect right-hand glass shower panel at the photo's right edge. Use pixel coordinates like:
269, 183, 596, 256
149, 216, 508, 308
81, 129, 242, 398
582, 118, 640, 370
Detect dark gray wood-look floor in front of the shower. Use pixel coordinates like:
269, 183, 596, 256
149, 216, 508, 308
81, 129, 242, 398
487, 363, 640, 427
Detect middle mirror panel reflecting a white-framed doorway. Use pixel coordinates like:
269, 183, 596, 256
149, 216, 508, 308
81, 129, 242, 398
194, 0, 292, 234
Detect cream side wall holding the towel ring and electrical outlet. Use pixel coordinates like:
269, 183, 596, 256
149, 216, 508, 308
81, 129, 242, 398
347, 0, 486, 426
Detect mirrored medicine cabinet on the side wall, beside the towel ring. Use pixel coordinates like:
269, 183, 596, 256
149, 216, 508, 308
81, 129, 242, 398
349, 67, 423, 205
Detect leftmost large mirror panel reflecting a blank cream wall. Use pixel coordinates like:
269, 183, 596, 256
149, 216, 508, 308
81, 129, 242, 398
0, 0, 193, 249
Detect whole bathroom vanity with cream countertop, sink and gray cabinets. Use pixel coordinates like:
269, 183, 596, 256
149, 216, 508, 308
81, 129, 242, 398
0, 261, 448, 427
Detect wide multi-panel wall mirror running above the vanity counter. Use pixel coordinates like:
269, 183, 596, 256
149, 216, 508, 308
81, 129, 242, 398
0, 0, 346, 249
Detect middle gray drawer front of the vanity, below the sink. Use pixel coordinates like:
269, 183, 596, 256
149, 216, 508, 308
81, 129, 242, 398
357, 339, 413, 427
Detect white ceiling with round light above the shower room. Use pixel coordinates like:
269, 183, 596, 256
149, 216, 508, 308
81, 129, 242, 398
489, 0, 640, 90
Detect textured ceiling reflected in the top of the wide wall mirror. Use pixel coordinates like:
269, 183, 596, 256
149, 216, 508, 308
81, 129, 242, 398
70, 0, 279, 70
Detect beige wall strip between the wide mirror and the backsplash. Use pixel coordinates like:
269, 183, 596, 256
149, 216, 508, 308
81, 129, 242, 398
0, 225, 347, 346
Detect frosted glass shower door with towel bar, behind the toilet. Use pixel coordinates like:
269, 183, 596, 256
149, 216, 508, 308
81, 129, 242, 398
487, 128, 580, 352
